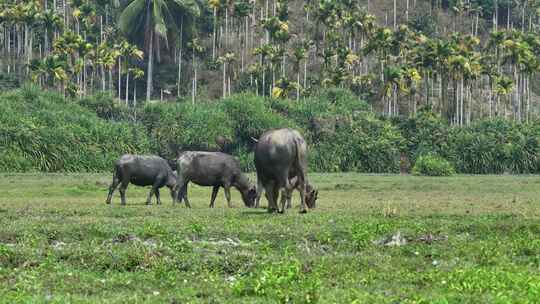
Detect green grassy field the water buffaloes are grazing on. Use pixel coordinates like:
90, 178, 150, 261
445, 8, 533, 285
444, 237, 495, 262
0, 174, 540, 303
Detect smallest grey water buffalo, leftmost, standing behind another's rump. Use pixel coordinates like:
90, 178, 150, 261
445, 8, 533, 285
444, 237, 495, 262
103, 154, 176, 205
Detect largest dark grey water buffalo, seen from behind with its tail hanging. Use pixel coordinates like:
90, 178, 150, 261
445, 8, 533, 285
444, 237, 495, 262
255, 129, 317, 213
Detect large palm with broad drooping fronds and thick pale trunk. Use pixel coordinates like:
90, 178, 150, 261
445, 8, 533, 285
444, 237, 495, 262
119, 0, 200, 101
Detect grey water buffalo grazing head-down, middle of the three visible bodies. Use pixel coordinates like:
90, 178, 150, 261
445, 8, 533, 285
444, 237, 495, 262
177, 151, 257, 208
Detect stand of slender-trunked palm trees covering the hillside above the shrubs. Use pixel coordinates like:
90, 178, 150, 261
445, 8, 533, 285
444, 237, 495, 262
0, 0, 540, 125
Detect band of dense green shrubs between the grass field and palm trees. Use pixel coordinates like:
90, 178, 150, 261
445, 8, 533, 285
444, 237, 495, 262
0, 87, 540, 175
